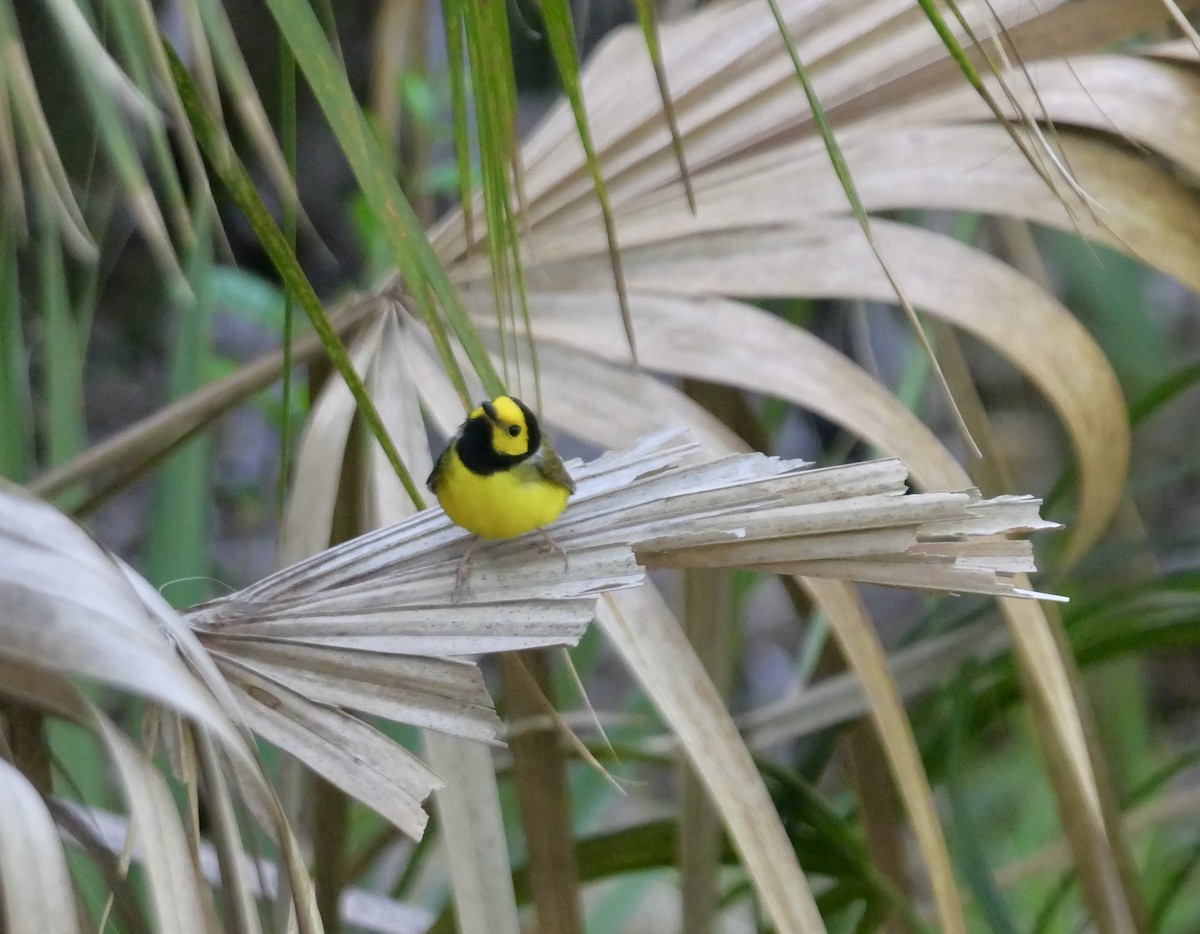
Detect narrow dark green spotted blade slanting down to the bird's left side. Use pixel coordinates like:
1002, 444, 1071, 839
167, 41, 425, 509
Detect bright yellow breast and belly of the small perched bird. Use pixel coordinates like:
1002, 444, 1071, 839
437, 450, 570, 538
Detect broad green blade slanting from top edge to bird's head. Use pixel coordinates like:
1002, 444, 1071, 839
258, 0, 504, 405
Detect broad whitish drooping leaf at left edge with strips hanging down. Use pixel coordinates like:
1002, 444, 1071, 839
0, 486, 319, 932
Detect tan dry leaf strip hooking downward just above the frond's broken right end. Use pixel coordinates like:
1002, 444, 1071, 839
523, 218, 1130, 555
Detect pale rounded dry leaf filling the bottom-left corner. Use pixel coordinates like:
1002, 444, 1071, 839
0, 758, 80, 934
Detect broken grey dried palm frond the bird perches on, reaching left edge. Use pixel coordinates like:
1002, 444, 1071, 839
0, 424, 1052, 849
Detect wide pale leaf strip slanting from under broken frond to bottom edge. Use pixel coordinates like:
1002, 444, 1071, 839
598, 586, 824, 933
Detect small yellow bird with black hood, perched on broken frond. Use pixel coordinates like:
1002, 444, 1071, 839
426, 396, 575, 587
